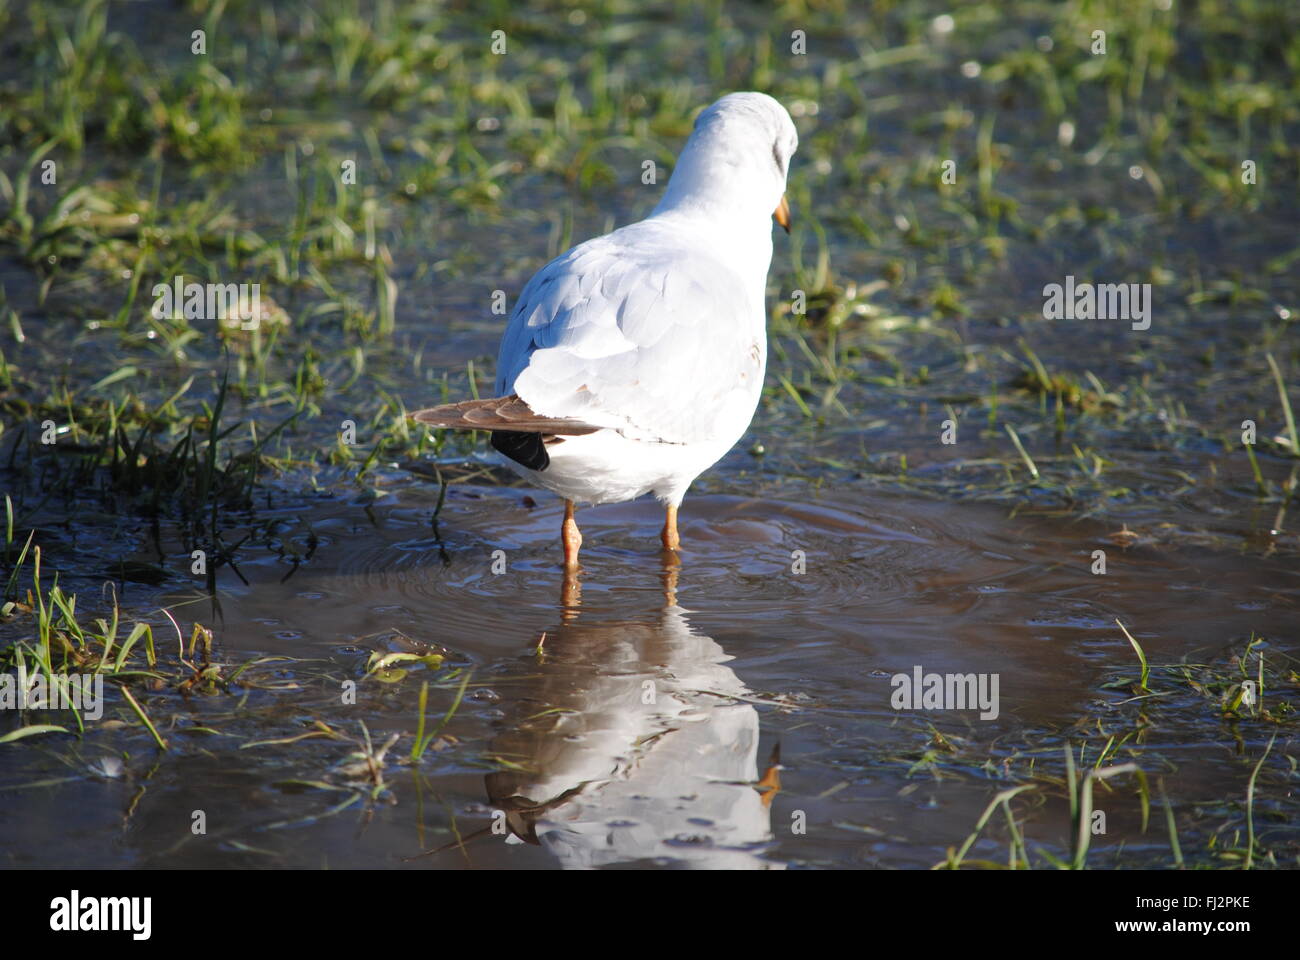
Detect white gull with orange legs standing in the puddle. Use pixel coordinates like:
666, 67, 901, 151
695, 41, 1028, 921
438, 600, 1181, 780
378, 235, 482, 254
412, 92, 798, 571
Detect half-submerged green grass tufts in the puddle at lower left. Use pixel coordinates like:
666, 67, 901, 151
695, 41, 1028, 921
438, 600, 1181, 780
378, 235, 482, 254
0, 522, 471, 829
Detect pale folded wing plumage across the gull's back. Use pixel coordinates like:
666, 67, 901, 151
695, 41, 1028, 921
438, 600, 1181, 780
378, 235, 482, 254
497, 221, 763, 444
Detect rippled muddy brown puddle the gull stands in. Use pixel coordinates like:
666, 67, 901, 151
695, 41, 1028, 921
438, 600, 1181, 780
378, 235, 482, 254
0, 477, 1300, 869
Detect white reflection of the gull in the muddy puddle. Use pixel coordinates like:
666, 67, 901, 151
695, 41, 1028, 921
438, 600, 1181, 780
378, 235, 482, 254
421, 557, 780, 869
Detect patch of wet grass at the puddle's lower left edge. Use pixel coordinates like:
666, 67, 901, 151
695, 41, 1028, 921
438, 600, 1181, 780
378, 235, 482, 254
0, 514, 483, 848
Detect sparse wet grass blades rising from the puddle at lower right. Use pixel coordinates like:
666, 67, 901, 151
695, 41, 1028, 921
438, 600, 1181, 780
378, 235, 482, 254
888, 624, 1300, 870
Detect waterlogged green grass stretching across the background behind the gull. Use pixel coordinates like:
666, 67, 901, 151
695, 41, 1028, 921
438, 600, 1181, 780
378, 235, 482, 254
0, 1, 1300, 530
